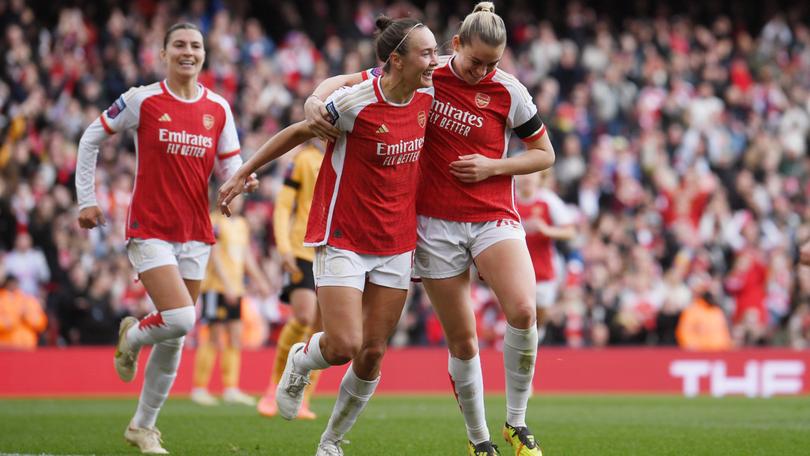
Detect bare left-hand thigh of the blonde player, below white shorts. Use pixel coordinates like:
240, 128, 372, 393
422, 271, 476, 351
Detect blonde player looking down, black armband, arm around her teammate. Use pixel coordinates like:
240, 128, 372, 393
306, 2, 554, 455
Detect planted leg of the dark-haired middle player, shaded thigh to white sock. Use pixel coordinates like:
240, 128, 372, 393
319, 282, 408, 454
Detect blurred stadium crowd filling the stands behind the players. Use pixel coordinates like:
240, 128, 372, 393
0, 0, 810, 349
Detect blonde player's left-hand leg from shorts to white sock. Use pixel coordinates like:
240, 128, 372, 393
422, 270, 490, 446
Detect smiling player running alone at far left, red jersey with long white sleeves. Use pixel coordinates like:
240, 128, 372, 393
76, 23, 258, 454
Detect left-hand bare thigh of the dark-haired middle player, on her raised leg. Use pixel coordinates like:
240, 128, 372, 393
318, 286, 363, 348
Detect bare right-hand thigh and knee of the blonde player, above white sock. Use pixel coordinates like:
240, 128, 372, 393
475, 239, 536, 326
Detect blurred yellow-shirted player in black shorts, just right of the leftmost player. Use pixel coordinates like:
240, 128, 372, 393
191, 199, 270, 405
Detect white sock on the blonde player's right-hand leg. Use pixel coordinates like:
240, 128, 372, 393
503, 324, 537, 426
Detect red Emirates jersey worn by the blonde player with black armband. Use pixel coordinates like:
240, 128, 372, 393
417, 58, 545, 222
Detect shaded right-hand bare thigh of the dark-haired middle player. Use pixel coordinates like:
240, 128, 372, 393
363, 282, 408, 348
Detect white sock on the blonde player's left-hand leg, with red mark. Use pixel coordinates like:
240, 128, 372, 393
447, 354, 489, 445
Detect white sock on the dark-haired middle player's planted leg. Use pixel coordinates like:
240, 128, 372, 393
321, 364, 380, 442
